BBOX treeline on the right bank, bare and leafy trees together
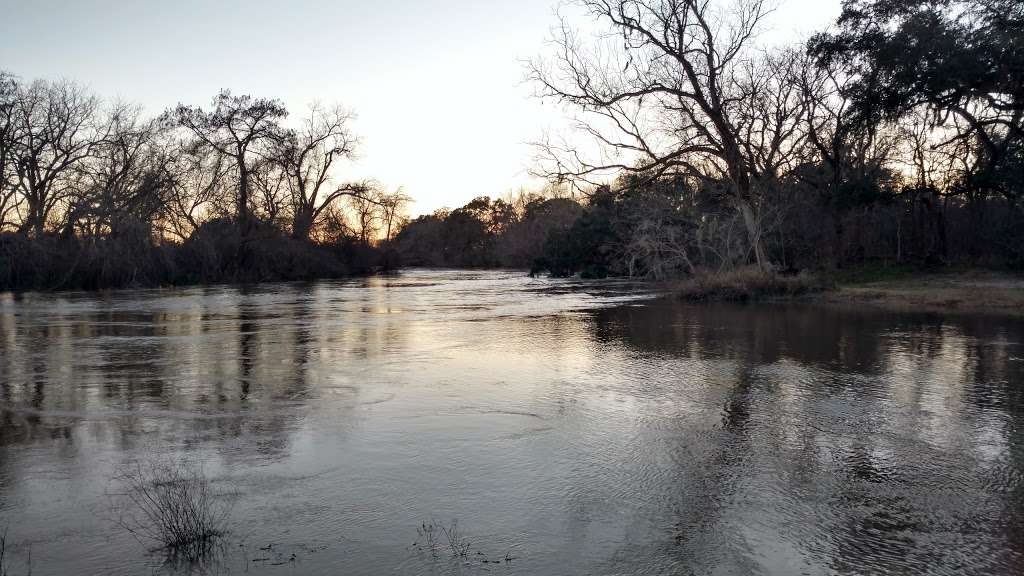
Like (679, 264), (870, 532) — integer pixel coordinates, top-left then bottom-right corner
(458, 0), (1024, 278)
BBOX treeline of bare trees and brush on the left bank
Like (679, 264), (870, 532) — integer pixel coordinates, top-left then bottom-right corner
(0, 77), (410, 290)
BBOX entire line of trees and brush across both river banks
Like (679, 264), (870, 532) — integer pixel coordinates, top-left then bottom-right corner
(9, 0), (1024, 289)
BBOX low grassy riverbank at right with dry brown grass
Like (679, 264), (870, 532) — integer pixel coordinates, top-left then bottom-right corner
(671, 266), (1024, 316)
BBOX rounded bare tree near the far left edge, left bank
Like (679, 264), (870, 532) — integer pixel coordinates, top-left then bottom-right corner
(12, 80), (106, 236)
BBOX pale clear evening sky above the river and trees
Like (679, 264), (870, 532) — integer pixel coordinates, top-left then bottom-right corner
(0, 0), (840, 215)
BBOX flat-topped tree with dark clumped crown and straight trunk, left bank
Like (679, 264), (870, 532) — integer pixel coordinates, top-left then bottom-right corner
(170, 90), (288, 231)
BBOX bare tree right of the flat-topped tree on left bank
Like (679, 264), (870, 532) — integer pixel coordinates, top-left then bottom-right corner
(276, 105), (375, 240)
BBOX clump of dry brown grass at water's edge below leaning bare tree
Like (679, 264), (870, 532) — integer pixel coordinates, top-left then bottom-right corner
(676, 266), (831, 302)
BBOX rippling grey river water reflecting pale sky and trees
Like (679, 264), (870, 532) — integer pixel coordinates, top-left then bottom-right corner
(0, 271), (1024, 576)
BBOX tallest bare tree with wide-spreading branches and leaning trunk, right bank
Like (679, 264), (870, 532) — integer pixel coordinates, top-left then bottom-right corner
(530, 0), (794, 266)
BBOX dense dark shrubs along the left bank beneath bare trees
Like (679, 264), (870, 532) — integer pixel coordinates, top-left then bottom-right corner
(0, 219), (387, 290)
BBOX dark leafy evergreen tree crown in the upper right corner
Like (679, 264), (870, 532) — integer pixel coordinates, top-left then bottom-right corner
(810, 0), (1024, 197)
